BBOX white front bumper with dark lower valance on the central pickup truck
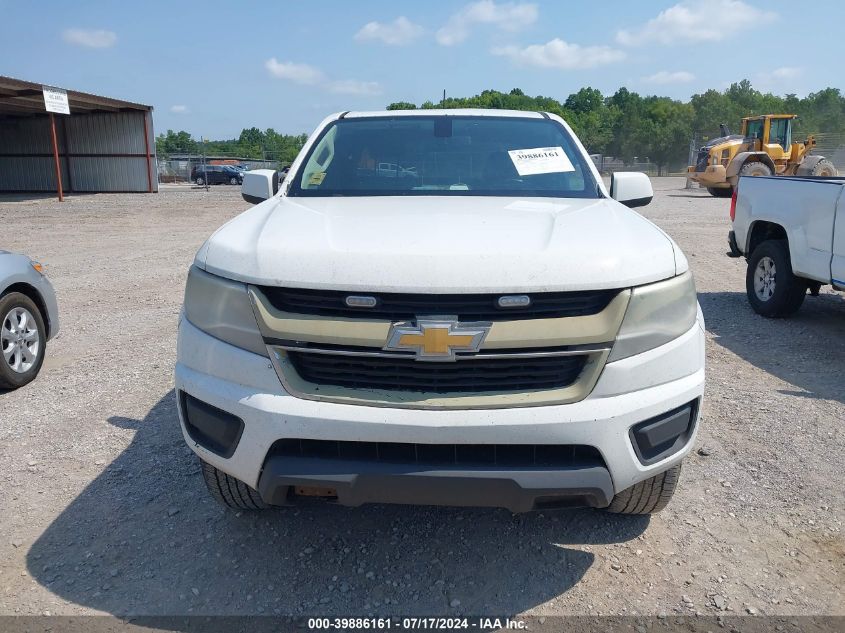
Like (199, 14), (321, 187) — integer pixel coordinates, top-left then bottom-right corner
(176, 310), (704, 511)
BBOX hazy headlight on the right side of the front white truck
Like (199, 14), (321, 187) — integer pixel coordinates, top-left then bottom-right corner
(607, 272), (698, 362)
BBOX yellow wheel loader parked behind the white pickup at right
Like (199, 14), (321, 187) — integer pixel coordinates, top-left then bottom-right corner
(687, 114), (839, 198)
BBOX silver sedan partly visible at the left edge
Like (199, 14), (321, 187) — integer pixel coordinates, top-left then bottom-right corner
(0, 251), (59, 389)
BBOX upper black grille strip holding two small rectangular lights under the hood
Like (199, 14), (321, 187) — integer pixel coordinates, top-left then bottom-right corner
(261, 286), (619, 321)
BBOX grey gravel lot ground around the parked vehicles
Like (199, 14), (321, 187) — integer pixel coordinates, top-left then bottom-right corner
(0, 178), (845, 615)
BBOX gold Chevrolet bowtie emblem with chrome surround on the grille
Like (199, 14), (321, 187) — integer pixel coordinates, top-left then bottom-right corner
(384, 319), (490, 361)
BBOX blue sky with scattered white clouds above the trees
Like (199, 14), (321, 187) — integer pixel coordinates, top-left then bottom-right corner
(0, 0), (845, 138)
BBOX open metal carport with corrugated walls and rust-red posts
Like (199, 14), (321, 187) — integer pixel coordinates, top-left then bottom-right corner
(0, 76), (158, 199)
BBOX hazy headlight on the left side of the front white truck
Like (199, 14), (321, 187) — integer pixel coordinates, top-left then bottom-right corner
(185, 266), (267, 356)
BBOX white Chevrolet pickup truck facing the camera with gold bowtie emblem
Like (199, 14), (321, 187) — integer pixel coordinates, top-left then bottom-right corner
(176, 110), (704, 514)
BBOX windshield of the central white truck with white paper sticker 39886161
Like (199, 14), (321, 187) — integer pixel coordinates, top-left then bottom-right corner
(288, 115), (601, 198)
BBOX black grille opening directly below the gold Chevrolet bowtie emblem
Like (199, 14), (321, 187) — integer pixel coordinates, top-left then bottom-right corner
(288, 352), (587, 393)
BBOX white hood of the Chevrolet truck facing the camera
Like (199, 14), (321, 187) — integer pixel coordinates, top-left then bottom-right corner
(201, 196), (686, 293)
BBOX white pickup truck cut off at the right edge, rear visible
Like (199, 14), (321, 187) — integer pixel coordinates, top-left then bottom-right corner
(728, 177), (845, 317)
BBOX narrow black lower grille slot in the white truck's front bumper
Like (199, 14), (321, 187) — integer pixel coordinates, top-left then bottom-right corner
(270, 438), (604, 467)
